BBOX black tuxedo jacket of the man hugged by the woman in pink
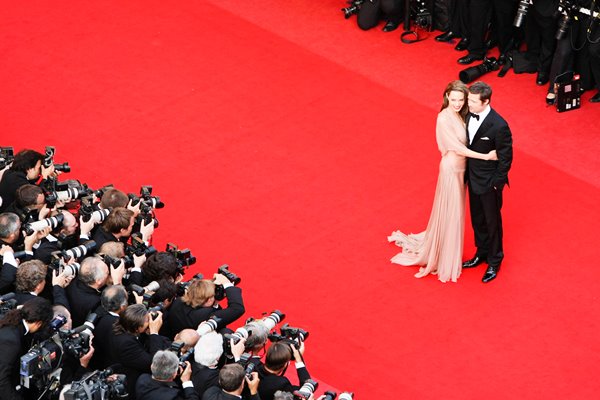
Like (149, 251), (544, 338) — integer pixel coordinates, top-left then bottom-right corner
(465, 108), (513, 194)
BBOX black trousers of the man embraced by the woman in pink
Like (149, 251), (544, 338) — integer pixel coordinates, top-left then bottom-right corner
(469, 186), (504, 266)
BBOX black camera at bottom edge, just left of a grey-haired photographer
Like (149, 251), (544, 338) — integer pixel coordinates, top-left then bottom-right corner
(64, 368), (129, 400)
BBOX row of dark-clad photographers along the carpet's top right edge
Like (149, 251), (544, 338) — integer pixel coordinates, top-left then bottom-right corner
(342, 0), (600, 105)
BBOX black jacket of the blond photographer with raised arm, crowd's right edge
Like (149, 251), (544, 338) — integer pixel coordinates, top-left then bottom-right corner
(161, 286), (245, 337)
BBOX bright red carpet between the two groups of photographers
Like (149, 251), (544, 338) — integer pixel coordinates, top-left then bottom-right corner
(0, 0), (600, 399)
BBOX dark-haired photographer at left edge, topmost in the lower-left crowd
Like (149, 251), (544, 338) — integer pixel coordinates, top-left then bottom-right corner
(0, 149), (54, 212)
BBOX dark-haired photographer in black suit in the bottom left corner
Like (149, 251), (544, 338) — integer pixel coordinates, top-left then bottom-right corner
(0, 297), (53, 400)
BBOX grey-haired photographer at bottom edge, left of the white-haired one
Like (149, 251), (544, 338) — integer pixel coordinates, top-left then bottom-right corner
(135, 350), (199, 400)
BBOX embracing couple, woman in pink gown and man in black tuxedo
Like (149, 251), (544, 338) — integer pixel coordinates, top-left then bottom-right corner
(388, 81), (513, 282)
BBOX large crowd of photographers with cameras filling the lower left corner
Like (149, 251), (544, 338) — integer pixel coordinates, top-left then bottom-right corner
(0, 147), (353, 400)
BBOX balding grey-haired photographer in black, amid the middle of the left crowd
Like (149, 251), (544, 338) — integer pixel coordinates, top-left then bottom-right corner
(67, 257), (109, 326)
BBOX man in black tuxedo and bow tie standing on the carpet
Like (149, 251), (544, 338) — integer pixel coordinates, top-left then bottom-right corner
(463, 82), (513, 283)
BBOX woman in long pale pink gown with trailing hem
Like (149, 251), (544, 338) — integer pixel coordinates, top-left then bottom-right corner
(388, 81), (496, 282)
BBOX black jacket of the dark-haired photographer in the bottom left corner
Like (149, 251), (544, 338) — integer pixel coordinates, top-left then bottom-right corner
(0, 323), (31, 400)
